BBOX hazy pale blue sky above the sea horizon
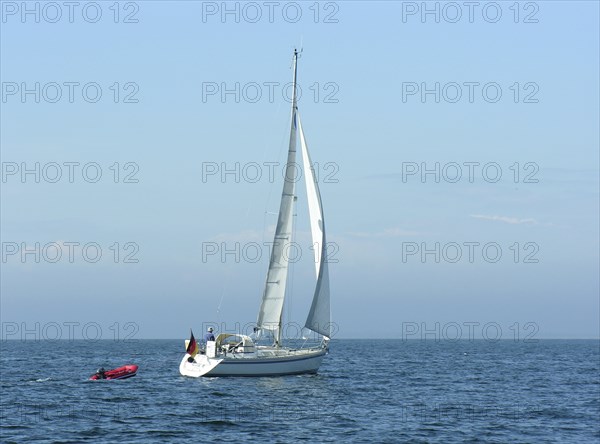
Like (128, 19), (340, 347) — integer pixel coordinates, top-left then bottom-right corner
(0, 1), (600, 339)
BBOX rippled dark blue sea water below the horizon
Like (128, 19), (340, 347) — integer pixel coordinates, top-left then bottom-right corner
(0, 340), (600, 443)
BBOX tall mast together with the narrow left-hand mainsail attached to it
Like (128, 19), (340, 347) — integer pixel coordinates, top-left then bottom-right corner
(256, 49), (298, 345)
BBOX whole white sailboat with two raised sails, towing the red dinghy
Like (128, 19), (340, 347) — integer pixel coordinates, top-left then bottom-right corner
(179, 50), (332, 377)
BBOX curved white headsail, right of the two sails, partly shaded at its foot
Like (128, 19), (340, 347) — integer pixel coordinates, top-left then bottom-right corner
(297, 115), (331, 337)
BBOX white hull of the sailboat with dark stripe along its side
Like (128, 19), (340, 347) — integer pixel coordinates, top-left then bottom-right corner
(179, 348), (327, 378)
